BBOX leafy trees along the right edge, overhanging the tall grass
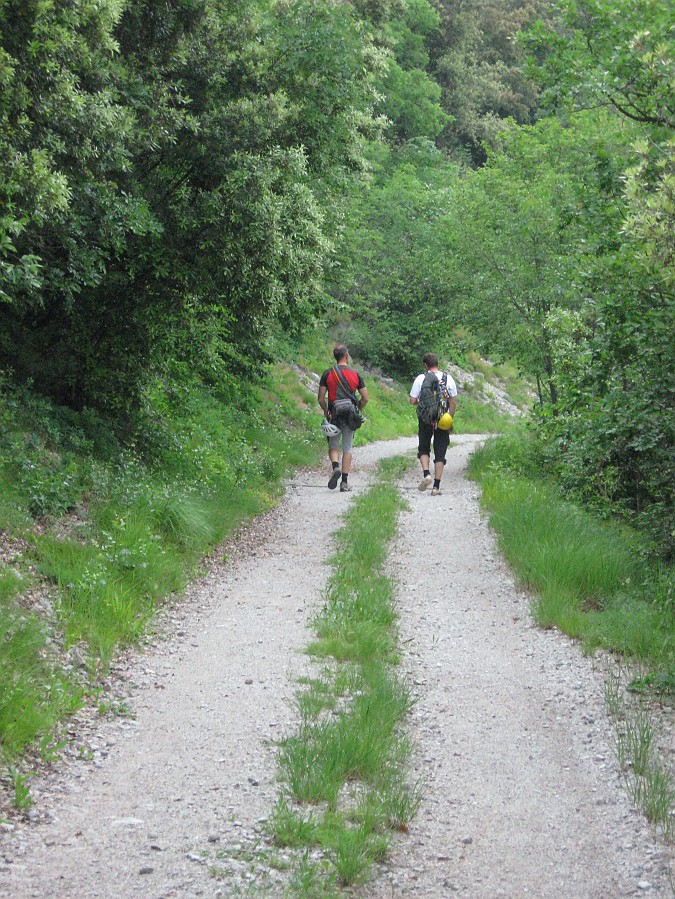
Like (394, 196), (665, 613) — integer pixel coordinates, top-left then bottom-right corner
(527, 0), (675, 555)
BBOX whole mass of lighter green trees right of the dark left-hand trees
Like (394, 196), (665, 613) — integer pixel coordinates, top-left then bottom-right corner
(329, 0), (675, 556)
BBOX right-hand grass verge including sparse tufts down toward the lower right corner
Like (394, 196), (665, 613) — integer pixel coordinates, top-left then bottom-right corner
(469, 438), (675, 839)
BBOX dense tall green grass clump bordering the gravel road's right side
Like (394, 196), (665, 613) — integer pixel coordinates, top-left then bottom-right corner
(470, 441), (675, 672)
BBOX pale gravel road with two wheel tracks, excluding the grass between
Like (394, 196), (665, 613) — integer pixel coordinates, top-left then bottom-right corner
(0, 437), (673, 899)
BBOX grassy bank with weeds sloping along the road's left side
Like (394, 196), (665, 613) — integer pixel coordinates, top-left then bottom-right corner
(0, 368), (324, 763)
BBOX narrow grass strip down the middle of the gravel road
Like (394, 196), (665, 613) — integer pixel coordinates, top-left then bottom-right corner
(269, 459), (420, 897)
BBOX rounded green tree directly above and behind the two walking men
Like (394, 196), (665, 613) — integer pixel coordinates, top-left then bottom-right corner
(328, 139), (458, 377)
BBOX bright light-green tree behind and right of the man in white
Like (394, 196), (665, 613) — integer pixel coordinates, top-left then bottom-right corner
(444, 120), (616, 403)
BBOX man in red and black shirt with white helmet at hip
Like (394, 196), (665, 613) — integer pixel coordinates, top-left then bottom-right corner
(317, 344), (368, 493)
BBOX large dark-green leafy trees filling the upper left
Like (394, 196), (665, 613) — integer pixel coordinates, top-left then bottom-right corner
(0, 0), (386, 415)
